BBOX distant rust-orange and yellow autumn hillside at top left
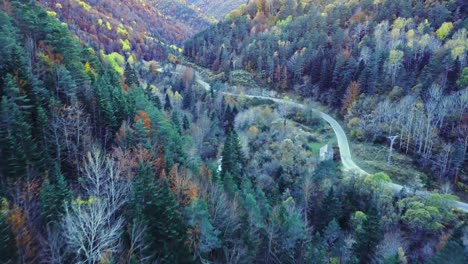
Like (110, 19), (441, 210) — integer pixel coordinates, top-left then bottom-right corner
(38, 0), (214, 60)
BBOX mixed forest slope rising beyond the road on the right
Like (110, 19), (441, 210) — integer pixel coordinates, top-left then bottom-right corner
(184, 0), (468, 194)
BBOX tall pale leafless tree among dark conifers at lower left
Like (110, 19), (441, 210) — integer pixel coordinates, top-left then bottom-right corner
(62, 149), (129, 264)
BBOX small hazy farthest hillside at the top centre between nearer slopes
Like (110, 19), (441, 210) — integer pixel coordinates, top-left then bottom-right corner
(187, 0), (249, 20)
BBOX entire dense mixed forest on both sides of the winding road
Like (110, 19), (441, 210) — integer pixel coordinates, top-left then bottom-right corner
(0, 0), (468, 264)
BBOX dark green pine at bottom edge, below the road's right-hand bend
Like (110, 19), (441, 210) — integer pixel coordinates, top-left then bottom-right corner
(353, 207), (384, 263)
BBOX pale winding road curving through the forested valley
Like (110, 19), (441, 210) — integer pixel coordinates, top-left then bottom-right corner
(196, 75), (468, 212)
